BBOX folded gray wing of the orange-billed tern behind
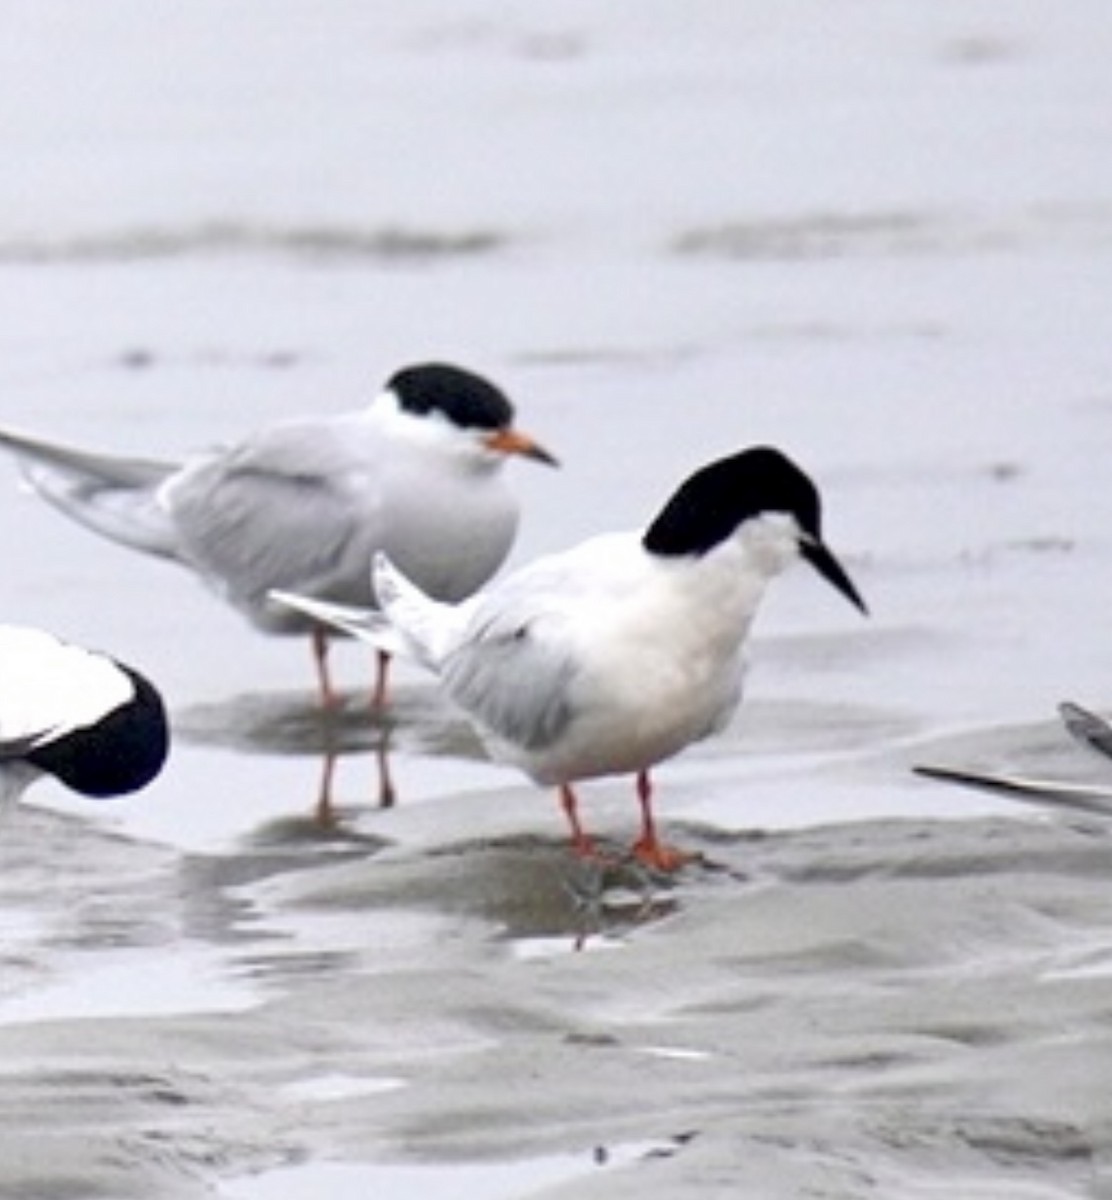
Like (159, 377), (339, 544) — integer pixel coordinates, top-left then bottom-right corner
(164, 422), (377, 607)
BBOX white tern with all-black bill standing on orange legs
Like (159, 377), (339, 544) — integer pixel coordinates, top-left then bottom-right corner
(278, 448), (865, 869)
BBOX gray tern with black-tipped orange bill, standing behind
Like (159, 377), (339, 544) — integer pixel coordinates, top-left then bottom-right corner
(0, 364), (555, 707)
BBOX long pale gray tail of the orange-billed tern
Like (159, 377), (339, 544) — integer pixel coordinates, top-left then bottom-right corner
(0, 430), (179, 559)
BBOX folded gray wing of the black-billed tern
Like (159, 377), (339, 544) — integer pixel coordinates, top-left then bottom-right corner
(441, 604), (577, 750)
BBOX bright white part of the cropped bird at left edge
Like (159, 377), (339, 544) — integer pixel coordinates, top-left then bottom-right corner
(0, 625), (134, 740)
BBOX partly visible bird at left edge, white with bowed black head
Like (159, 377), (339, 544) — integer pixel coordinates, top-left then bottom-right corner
(0, 625), (169, 799)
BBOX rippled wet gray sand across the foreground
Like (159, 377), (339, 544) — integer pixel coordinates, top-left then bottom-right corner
(0, 792), (1112, 1200)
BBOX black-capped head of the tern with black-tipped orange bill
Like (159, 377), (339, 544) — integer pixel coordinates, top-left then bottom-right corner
(384, 362), (558, 467)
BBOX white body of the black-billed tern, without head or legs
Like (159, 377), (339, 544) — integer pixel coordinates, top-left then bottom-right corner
(388, 533), (763, 785)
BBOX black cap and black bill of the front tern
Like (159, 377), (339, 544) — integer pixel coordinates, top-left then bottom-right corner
(643, 446), (866, 612)
